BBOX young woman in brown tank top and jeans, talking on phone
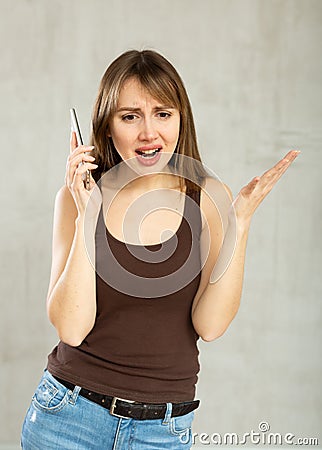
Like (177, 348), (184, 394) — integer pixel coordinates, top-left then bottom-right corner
(21, 50), (298, 450)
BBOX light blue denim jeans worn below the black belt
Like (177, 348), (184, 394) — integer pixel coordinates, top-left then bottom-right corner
(21, 370), (194, 450)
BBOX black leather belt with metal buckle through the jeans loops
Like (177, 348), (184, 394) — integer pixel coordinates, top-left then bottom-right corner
(55, 377), (200, 420)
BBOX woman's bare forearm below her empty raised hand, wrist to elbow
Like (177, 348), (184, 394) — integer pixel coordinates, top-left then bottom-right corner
(192, 224), (249, 341)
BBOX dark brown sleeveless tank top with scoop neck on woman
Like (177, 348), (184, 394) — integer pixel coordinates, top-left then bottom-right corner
(47, 184), (201, 403)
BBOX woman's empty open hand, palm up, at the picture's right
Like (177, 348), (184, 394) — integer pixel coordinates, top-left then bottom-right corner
(233, 150), (300, 225)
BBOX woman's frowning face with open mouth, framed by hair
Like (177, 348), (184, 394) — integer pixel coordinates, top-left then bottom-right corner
(110, 78), (180, 170)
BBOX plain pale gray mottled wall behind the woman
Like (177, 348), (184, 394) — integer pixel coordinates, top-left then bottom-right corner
(0, 0), (322, 449)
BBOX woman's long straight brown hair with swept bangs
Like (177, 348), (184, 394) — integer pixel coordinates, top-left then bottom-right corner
(91, 50), (208, 190)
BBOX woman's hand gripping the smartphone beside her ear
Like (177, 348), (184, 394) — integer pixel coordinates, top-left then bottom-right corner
(65, 131), (102, 217)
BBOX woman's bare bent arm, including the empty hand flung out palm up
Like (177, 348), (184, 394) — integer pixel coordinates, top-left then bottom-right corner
(192, 151), (298, 341)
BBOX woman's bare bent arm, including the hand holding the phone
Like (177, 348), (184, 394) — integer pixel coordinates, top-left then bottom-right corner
(47, 134), (100, 346)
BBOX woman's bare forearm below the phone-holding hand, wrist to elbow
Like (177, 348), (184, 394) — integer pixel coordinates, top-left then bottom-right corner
(47, 217), (96, 346)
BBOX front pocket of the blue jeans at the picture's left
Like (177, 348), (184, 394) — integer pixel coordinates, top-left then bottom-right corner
(32, 374), (72, 413)
